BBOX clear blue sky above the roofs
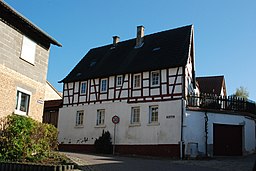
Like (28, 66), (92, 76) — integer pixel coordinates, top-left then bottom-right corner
(5, 0), (256, 100)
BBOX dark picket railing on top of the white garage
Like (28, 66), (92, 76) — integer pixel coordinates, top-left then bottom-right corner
(187, 94), (256, 115)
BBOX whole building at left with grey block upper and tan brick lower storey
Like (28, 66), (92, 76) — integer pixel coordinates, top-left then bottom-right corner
(0, 1), (61, 121)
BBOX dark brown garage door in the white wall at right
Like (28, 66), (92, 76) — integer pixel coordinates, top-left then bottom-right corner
(213, 124), (243, 156)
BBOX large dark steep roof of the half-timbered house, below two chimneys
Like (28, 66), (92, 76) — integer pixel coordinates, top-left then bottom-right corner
(61, 25), (193, 83)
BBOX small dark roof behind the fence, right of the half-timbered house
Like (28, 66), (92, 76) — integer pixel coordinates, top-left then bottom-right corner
(196, 76), (226, 96)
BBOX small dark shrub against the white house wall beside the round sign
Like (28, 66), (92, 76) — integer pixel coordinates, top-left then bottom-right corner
(94, 130), (113, 154)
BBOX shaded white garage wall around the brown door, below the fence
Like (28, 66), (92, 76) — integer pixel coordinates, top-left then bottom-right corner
(183, 110), (255, 156)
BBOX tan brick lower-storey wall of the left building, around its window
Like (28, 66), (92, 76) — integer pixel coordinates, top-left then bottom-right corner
(0, 65), (45, 121)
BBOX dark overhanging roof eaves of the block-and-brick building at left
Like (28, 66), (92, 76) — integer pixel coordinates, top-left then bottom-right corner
(0, 0), (62, 49)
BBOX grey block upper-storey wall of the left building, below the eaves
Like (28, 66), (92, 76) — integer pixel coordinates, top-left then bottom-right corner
(0, 21), (49, 83)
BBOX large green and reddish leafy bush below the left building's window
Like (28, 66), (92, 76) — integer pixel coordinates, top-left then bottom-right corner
(0, 114), (58, 162)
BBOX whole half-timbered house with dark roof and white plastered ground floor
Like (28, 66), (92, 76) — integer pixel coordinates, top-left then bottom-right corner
(58, 25), (195, 156)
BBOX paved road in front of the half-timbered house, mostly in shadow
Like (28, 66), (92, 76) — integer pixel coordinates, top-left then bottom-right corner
(63, 153), (256, 171)
